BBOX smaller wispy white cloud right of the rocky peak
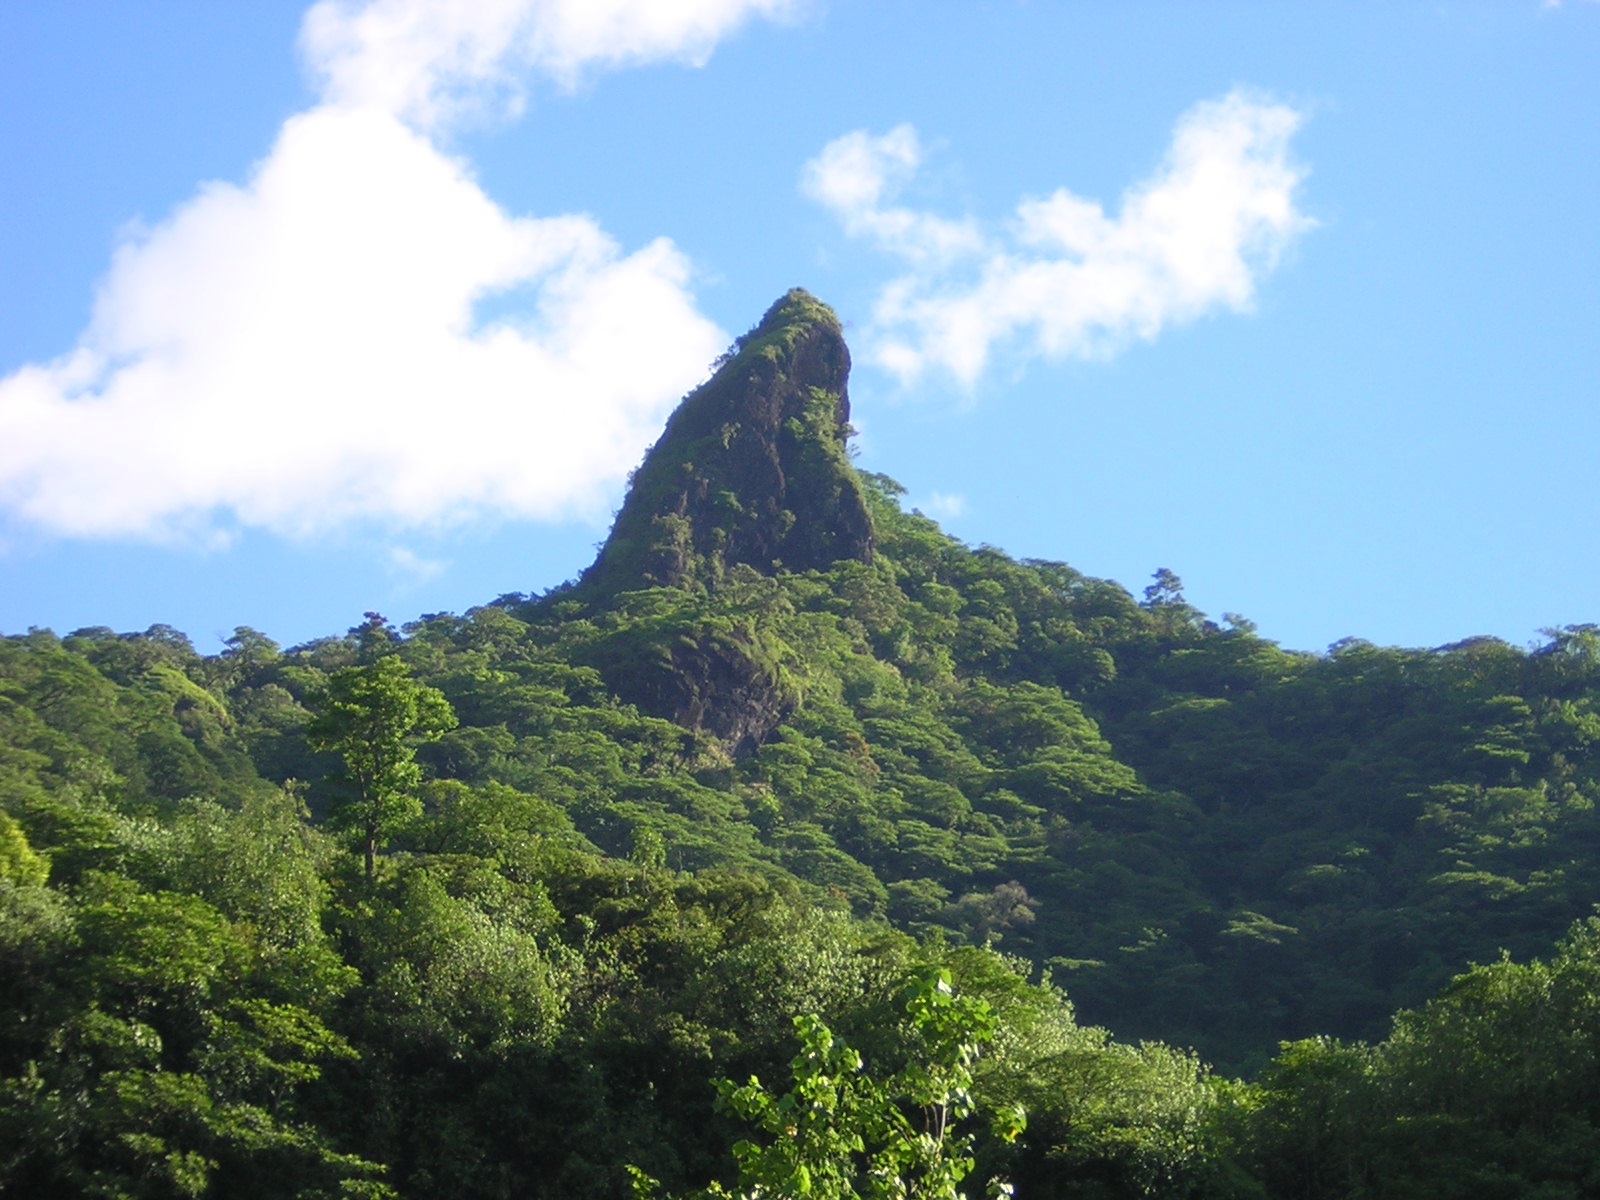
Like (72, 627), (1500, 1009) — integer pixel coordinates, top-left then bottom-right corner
(802, 91), (1312, 384)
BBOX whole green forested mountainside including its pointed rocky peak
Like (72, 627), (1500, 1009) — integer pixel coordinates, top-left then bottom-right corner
(0, 293), (1600, 1197)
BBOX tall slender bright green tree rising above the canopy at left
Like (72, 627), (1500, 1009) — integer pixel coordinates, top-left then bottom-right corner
(306, 654), (456, 882)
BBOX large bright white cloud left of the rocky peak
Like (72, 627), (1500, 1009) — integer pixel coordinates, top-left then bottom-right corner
(0, 0), (782, 541)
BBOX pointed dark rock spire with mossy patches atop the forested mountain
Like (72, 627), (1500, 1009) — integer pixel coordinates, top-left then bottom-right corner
(582, 288), (872, 594)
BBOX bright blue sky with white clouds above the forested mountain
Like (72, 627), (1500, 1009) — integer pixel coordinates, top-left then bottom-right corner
(0, 0), (1600, 650)
